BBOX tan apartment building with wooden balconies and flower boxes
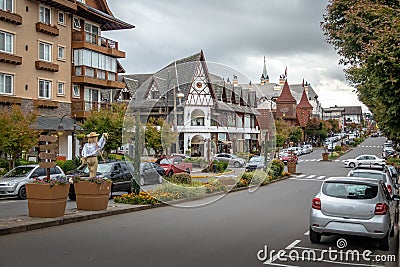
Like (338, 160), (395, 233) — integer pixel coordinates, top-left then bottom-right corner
(0, 0), (134, 159)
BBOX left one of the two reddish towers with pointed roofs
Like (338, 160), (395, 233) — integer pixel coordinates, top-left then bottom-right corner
(276, 81), (297, 122)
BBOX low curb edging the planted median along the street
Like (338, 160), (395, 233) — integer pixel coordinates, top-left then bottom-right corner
(0, 176), (290, 236)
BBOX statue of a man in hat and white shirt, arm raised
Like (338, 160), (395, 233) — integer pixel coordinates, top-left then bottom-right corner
(82, 132), (108, 177)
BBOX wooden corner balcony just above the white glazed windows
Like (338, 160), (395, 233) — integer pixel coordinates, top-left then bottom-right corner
(72, 31), (125, 58)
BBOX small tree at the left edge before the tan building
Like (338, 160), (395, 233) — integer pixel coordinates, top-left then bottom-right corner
(0, 105), (39, 168)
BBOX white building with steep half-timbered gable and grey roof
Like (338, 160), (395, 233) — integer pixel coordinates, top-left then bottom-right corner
(124, 51), (260, 157)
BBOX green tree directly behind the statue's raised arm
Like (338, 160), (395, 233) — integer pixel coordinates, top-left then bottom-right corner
(82, 104), (126, 154)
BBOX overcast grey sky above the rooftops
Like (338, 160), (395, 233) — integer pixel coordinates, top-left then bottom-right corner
(104, 0), (368, 110)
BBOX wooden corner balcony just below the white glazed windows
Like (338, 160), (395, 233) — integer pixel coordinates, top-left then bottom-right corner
(72, 66), (125, 89)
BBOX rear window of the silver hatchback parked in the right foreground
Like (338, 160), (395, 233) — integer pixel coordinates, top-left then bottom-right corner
(322, 182), (378, 199)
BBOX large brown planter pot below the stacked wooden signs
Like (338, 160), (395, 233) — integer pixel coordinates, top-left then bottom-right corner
(25, 175), (70, 218)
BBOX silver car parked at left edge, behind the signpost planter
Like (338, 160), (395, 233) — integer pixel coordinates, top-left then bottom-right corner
(0, 165), (65, 199)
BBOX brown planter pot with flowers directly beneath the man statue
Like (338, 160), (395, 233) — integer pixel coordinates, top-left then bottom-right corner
(73, 176), (112, 213)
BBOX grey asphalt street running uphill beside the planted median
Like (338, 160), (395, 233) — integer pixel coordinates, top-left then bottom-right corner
(0, 138), (398, 267)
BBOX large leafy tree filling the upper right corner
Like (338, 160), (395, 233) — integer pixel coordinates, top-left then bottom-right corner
(321, 0), (400, 141)
